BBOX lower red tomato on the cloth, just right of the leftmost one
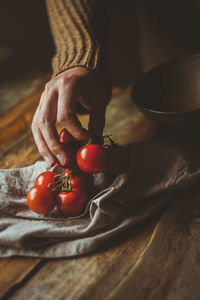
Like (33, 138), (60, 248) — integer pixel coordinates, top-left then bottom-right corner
(57, 187), (87, 217)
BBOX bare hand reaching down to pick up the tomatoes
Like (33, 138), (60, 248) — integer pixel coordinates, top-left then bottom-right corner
(31, 67), (110, 166)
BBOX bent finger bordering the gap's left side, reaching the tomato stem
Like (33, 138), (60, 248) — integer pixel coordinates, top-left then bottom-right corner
(57, 88), (89, 141)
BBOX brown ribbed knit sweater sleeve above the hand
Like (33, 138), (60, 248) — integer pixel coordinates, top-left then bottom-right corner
(46, 0), (104, 77)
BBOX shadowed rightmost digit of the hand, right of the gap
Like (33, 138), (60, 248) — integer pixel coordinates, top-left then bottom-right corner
(88, 106), (106, 136)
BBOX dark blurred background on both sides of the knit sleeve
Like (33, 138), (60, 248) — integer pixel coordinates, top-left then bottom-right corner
(0, 0), (200, 85)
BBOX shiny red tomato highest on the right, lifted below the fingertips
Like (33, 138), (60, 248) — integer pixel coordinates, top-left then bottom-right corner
(76, 144), (107, 174)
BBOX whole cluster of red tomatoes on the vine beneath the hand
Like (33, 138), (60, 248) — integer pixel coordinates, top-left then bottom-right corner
(27, 128), (128, 217)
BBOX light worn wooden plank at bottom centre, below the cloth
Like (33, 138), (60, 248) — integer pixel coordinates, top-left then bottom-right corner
(10, 219), (155, 300)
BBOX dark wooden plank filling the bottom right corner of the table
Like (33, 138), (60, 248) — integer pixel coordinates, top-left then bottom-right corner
(105, 189), (200, 300)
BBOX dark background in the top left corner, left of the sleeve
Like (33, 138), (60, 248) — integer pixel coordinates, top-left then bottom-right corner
(0, 0), (55, 75)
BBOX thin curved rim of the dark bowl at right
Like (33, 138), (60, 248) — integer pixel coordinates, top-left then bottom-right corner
(131, 53), (200, 115)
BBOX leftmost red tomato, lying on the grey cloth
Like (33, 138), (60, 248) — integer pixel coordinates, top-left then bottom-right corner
(27, 185), (56, 214)
